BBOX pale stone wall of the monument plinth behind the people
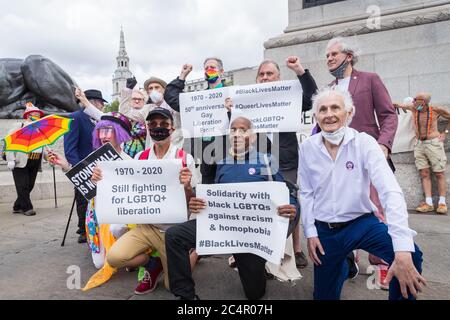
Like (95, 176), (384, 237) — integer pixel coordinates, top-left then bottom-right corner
(264, 0), (450, 208)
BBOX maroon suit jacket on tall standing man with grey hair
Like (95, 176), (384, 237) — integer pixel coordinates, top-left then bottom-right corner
(332, 70), (398, 150)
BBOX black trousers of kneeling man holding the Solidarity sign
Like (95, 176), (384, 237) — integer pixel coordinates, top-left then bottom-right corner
(165, 214), (299, 300)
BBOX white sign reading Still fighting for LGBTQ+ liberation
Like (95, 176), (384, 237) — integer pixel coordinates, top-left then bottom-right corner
(95, 159), (187, 224)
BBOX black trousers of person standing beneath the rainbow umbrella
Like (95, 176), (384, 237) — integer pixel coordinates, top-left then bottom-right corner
(13, 158), (41, 211)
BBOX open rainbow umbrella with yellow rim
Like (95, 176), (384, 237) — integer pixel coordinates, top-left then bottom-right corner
(3, 115), (72, 153)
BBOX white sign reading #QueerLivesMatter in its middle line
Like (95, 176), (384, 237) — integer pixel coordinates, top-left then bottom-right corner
(230, 80), (303, 132)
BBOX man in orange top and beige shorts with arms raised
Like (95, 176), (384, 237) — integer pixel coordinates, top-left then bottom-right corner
(394, 93), (450, 214)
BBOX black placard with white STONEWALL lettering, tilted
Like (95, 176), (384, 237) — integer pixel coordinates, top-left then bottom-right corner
(66, 143), (122, 201)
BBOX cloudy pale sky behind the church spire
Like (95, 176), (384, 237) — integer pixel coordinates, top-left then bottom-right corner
(0, 0), (288, 100)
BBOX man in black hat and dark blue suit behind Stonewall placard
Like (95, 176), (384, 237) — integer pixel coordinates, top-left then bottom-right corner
(64, 90), (107, 243)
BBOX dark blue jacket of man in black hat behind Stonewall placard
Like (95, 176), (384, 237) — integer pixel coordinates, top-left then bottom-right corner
(64, 110), (95, 166)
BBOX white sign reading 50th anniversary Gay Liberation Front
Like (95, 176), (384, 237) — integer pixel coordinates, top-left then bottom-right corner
(180, 88), (229, 138)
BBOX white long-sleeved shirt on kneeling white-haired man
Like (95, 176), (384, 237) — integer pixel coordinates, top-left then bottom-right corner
(299, 128), (417, 252)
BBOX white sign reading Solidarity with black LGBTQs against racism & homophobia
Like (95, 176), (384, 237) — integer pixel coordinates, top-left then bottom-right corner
(196, 182), (289, 265)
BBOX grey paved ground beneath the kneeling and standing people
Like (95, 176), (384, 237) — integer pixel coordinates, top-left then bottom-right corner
(0, 198), (450, 300)
